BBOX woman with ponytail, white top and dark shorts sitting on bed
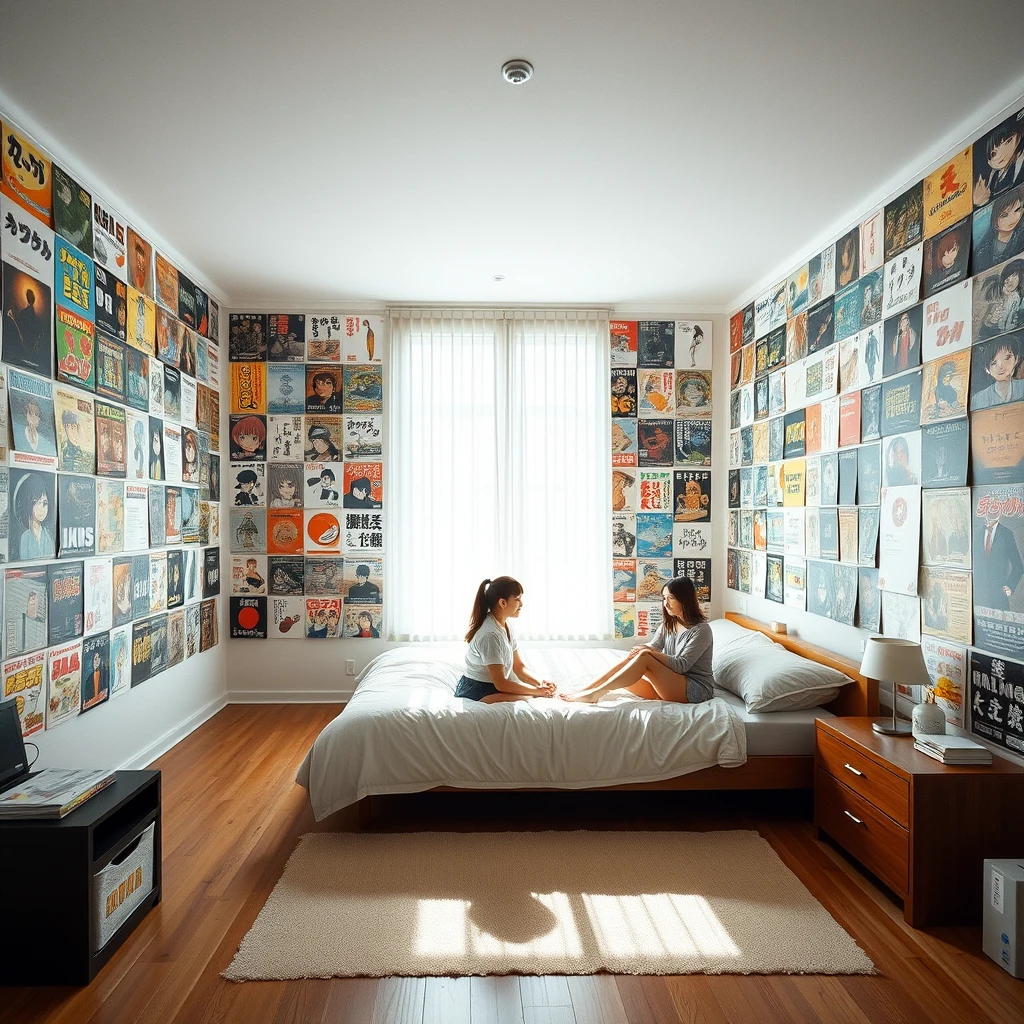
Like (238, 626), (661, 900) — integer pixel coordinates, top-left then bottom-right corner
(455, 577), (555, 703)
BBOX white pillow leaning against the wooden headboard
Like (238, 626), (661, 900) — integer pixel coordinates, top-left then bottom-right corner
(712, 630), (850, 712)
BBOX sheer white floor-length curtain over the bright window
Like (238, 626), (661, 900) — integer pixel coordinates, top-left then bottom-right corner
(384, 309), (612, 640)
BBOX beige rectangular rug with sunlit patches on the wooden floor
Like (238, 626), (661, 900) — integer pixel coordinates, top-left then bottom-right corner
(224, 831), (874, 981)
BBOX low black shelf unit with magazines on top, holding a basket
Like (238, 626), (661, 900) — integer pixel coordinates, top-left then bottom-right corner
(0, 770), (161, 985)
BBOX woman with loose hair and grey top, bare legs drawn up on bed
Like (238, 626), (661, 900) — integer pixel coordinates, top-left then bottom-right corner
(559, 577), (715, 703)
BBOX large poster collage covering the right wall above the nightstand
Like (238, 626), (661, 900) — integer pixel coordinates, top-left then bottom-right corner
(727, 109), (1024, 754)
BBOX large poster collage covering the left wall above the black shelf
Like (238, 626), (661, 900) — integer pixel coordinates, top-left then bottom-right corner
(0, 119), (220, 736)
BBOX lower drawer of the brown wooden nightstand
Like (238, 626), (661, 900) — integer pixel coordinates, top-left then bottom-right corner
(814, 770), (909, 895)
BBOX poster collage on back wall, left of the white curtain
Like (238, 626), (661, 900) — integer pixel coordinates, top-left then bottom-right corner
(225, 311), (384, 640)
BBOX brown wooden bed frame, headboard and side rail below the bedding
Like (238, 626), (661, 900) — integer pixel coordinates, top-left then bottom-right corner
(358, 611), (879, 824)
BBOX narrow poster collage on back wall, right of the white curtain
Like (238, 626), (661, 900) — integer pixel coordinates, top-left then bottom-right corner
(609, 321), (712, 638)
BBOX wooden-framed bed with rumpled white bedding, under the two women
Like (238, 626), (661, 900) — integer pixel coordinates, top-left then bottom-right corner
(296, 612), (878, 820)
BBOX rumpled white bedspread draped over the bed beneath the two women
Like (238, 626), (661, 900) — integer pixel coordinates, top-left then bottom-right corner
(296, 645), (746, 820)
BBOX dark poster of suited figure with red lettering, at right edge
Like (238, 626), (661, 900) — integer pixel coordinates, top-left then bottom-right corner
(972, 483), (1024, 654)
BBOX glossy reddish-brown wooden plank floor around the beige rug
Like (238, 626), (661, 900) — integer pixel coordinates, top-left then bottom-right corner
(0, 706), (1024, 1024)
